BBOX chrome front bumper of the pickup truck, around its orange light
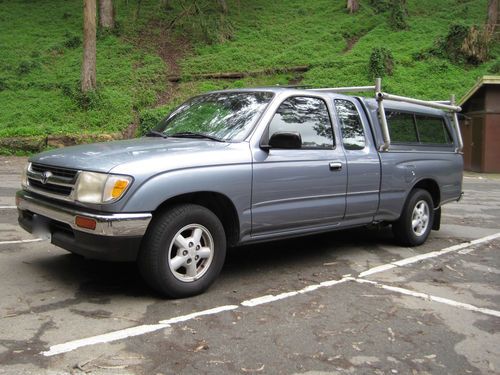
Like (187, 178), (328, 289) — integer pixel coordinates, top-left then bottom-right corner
(16, 190), (152, 237)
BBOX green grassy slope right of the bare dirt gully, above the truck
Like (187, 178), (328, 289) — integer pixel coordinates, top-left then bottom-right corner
(178, 0), (500, 99)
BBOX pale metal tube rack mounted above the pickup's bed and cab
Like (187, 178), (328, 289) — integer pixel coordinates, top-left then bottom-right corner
(311, 78), (463, 152)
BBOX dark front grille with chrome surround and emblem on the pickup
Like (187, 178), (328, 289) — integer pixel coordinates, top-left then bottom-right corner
(28, 163), (78, 199)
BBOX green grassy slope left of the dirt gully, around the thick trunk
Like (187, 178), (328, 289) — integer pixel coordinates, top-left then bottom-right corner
(0, 0), (165, 137)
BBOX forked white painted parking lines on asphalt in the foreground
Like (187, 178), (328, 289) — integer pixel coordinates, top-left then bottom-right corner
(39, 232), (500, 357)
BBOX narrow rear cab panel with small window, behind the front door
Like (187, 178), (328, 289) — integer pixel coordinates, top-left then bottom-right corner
(334, 99), (380, 225)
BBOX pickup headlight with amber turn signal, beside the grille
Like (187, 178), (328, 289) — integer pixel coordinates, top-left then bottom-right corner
(75, 172), (132, 203)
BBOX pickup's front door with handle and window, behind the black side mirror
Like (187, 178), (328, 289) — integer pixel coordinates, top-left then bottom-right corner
(252, 96), (347, 235)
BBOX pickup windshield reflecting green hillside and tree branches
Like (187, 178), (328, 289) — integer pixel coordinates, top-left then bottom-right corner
(155, 92), (273, 141)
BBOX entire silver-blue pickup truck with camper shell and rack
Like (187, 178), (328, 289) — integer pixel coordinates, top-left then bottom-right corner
(16, 80), (463, 297)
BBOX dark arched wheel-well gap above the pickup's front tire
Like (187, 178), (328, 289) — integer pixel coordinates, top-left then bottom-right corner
(153, 191), (240, 246)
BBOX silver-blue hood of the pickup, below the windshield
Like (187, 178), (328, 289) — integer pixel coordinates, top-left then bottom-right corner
(30, 137), (230, 172)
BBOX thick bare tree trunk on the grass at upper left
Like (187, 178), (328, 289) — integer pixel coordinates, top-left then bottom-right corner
(82, 0), (96, 92)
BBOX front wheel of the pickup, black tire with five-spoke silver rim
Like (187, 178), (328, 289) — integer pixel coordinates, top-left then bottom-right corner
(138, 204), (226, 298)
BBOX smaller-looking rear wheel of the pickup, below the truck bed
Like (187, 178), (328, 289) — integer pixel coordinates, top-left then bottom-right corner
(392, 189), (434, 246)
